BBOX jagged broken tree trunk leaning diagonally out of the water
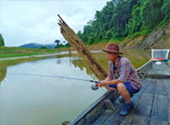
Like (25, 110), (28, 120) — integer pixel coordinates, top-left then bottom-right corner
(58, 15), (107, 80)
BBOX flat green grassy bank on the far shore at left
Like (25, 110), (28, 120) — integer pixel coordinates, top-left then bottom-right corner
(0, 47), (58, 58)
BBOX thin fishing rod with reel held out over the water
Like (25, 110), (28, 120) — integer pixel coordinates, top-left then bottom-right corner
(8, 73), (99, 90)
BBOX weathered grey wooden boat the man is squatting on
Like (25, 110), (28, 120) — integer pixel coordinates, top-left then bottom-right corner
(69, 50), (170, 125)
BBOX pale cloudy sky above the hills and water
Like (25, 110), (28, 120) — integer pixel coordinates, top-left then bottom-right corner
(0, 0), (110, 46)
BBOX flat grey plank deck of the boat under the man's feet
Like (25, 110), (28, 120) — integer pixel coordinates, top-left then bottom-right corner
(95, 78), (170, 125)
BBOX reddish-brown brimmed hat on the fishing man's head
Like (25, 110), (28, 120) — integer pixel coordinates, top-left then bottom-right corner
(103, 43), (123, 54)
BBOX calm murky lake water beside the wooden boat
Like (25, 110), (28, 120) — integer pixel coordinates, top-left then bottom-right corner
(0, 50), (150, 125)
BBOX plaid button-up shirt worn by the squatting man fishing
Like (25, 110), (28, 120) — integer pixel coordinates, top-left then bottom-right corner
(108, 56), (142, 90)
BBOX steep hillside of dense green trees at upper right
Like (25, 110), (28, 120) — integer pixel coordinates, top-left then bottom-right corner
(77, 0), (170, 48)
